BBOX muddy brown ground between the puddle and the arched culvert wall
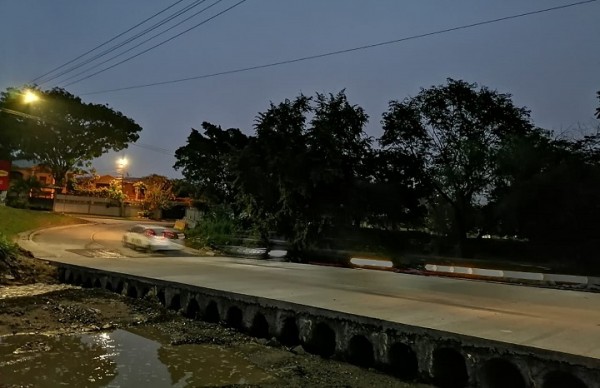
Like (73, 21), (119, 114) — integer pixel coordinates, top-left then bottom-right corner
(0, 257), (432, 387)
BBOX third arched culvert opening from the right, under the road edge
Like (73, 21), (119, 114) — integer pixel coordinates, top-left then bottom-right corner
(432, 348), (469, 388)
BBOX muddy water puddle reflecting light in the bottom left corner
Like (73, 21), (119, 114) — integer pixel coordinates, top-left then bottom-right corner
(0, 328), (274, 388)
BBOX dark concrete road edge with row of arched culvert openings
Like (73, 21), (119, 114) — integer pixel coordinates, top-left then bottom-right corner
(56, 263), (600, 388)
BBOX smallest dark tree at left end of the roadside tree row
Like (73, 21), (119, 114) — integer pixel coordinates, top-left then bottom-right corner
(174, 122), (248, 204)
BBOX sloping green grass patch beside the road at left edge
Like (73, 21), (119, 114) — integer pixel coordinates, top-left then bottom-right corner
(0, 206), (86, 239)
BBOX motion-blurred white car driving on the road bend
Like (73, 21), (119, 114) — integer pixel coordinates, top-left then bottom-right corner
(122, 225), (183, 251)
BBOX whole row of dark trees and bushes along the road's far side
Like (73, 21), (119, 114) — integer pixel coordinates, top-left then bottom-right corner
(175, 79), (600, 273)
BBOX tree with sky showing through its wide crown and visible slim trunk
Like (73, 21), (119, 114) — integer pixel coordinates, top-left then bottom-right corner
(380, 79), (532, 254)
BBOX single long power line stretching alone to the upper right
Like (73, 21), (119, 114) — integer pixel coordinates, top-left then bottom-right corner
(81, 0), (598, 96)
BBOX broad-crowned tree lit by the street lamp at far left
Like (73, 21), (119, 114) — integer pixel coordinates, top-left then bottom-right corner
(0, 88), (142, 185)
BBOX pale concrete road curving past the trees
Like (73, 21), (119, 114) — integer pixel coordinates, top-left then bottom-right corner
(22, 221), (600, 361)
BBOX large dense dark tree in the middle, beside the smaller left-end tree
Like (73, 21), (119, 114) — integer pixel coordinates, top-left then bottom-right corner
(237, 91), (371, 255)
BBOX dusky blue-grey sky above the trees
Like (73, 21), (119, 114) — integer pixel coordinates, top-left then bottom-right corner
(0, 0), (600, 177)
